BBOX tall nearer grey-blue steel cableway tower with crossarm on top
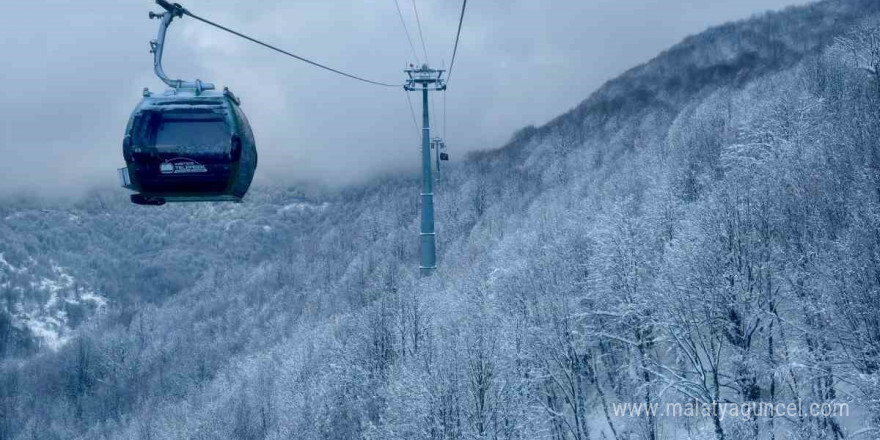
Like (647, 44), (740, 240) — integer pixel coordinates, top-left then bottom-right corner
(403, 64), (446, 276)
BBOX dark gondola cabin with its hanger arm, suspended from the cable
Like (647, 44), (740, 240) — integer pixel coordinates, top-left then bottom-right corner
(119, 1), (257, 206)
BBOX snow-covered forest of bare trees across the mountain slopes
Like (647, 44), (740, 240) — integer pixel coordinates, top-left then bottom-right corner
(0, 0), (880, 440)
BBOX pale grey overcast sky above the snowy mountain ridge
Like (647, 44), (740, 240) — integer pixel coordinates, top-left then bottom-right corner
(0, 0), (803, 199)
